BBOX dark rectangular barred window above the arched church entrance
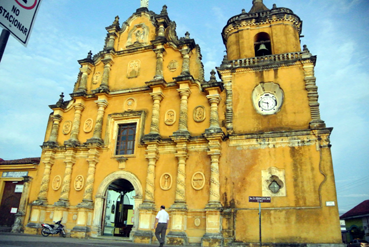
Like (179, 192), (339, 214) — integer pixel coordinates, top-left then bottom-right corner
(115, 124), (136, 155)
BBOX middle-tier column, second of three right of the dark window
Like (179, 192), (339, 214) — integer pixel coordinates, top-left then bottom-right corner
(174, 87), (191, 135)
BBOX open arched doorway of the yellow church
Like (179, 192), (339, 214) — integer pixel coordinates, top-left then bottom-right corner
(101, 178), (136, 237)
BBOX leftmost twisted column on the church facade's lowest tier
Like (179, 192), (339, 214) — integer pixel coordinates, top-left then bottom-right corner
(34, 151), (55, 204)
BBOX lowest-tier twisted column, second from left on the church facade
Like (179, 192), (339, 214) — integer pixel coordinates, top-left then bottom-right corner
(54, 149), (76, 207)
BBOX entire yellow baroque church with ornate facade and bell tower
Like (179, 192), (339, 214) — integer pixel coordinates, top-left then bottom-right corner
(1, 0), (342, 246)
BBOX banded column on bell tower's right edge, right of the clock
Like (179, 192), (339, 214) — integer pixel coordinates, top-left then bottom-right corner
(302, 45), (325, 129)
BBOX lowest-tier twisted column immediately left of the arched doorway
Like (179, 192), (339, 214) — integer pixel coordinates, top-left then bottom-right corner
(78, 148), (100, 208)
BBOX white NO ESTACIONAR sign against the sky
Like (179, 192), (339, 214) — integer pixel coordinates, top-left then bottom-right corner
(0, 0), (41, 46)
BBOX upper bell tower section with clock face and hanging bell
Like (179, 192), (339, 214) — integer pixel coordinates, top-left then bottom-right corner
(218, 0), (325, 133)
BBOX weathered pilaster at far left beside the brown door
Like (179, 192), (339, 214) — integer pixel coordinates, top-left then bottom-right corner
(11, 176), (32, 233)
